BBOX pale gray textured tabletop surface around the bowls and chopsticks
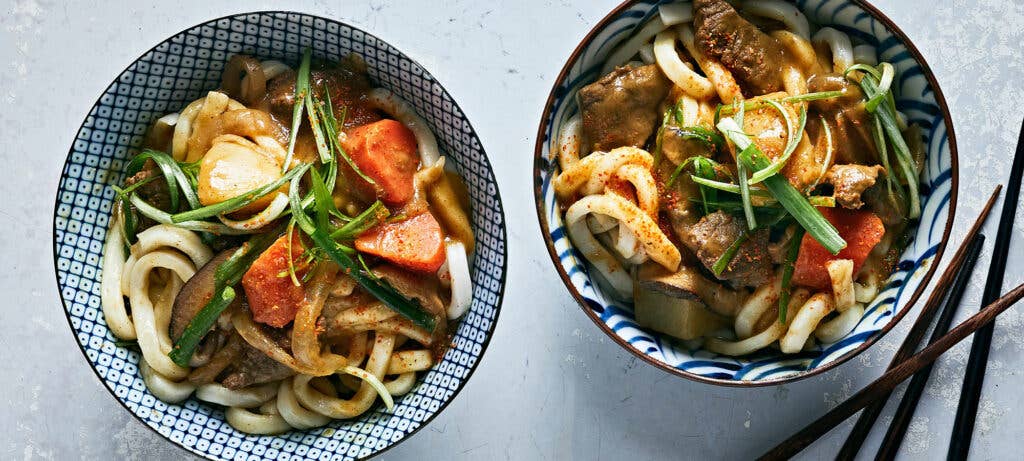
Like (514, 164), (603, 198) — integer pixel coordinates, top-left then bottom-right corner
(0, 0), (1024, 460)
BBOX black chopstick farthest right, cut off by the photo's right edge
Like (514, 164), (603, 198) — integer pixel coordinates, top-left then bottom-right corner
(946, 117), (1024, 460)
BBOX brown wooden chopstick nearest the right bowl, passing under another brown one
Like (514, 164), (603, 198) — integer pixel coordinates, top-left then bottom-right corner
(836, 185), (1002, 461)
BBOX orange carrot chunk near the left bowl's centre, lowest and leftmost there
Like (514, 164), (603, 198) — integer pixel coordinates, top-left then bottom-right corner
(242, 234), (308, 328)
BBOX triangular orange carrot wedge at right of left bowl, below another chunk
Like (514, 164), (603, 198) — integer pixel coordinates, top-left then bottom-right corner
(355, 211), (445, 273)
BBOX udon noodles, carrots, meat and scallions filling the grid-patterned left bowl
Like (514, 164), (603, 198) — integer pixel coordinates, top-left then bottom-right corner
(101, 50), (474, 434)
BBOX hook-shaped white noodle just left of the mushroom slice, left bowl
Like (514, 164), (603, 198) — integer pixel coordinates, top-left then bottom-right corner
(128, 250), (196, 380)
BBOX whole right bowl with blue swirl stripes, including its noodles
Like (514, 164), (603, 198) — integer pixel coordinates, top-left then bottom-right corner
(534, 0), (956, 386)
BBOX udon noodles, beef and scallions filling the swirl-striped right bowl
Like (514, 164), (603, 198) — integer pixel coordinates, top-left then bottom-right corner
(552, 0), (925, 355)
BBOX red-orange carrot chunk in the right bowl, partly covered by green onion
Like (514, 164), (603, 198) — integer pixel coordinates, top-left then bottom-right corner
(793, 208), (886, 290)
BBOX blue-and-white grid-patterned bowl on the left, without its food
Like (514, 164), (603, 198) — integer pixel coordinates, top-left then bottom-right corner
(53, 12), (507, 460)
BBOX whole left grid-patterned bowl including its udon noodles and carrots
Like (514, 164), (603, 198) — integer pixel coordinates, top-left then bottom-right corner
(54, 11), (506, 460)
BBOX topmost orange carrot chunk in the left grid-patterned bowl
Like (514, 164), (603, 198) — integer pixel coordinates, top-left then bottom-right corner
(342, 120), (420, 206)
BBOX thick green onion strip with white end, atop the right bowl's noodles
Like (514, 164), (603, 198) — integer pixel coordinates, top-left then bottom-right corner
(718, 118), (846, 254)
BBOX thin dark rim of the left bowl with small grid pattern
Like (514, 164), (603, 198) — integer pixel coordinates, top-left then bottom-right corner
(51, 9), (508, 460)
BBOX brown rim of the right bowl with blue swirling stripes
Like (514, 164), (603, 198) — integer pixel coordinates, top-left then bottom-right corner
(532, 0), (959, 387)
